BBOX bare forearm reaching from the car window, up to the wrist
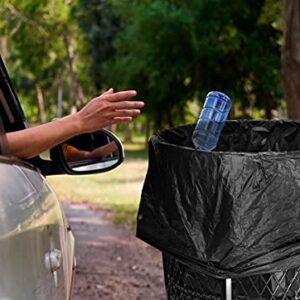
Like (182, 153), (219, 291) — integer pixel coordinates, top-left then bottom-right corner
(7, 114), (82, 159)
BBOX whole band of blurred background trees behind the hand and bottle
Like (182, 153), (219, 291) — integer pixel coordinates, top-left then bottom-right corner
(0, 0), (292, 137)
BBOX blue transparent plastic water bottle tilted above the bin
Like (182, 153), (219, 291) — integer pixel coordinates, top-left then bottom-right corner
(193, 91), (231, 151)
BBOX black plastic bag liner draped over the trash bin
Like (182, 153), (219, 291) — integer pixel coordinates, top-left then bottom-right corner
(137, 121), (300, 278)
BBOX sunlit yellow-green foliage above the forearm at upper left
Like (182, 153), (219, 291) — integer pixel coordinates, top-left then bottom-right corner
(0, 0), (88, 122)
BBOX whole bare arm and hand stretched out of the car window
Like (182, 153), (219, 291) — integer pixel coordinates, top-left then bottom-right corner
(7, 89), (144, 159)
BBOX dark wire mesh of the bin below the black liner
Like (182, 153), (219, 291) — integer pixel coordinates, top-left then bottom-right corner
(163, 254), (300, 300)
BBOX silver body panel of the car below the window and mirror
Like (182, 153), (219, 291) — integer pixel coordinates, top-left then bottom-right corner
(0, 158), (74, 300)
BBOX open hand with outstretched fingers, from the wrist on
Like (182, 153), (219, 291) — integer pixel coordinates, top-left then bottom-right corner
(74, 89), (144, 132)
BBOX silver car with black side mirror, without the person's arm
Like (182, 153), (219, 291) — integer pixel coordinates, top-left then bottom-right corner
(0, 57), (124, 300)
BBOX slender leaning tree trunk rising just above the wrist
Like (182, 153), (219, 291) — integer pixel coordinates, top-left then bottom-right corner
(64, 35), (83, 109)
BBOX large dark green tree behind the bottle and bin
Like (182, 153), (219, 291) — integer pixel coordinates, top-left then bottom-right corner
(103, 0), (281, 128)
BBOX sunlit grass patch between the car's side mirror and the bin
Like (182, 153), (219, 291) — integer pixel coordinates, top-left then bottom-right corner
(48, 139), (148, 227)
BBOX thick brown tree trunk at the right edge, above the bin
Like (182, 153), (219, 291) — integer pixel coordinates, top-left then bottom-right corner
(281, 0), (300, 119)
